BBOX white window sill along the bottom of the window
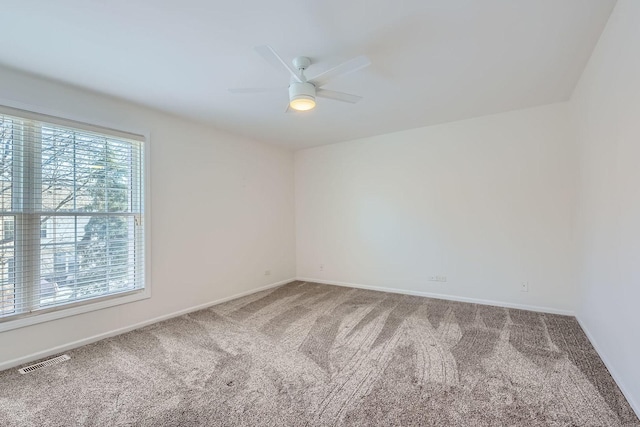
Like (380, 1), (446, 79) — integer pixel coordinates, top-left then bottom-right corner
(0, 287), (151, 332)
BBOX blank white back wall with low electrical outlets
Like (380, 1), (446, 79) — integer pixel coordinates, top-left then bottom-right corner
(295, 103), (576, 312)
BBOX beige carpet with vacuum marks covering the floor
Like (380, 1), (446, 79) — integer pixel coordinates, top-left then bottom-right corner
(0, 282), (640, 427)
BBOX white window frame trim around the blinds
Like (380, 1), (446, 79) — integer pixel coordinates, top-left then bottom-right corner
(0, 98), (151, 332)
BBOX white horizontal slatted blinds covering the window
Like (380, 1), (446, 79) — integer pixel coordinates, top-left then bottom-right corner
(0, 107), (145, 322)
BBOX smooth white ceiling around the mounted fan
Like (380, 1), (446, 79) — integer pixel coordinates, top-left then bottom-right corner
(0, 0), (615, 149)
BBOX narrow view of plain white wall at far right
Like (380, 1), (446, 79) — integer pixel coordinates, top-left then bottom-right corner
(571, 0), (640, 413)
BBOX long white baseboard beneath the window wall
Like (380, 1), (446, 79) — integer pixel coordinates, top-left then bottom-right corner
(0, 278), (296, 371)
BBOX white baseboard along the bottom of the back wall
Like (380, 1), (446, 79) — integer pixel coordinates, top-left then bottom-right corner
(297, 277), (575, 316)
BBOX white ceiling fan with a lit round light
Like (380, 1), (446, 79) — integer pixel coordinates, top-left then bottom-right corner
(229, 45), (371, 111)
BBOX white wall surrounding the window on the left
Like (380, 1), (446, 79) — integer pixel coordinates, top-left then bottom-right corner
(0, 68), (295, 369)
